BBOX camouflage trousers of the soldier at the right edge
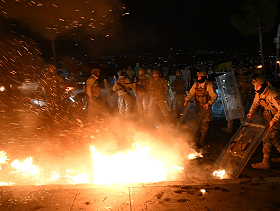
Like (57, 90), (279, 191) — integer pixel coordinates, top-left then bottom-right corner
(262, 123), (280, 156)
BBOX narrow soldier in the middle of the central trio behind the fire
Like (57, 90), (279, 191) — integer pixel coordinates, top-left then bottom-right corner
(136, 67), (149, 120)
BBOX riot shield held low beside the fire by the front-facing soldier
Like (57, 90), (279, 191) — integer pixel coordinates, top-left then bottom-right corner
(177, 102), (205, 143)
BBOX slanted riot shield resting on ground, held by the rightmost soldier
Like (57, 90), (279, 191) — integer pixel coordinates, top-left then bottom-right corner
(214, 114), (267, 178)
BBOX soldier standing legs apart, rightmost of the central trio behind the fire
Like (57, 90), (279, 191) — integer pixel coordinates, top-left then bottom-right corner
(148, 70), (169, 121)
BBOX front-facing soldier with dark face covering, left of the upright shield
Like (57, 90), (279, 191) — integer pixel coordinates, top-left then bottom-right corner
(184, 70), (218, 147)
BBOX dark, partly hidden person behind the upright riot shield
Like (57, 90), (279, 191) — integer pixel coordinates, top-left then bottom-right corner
(222, 68), (252, 133)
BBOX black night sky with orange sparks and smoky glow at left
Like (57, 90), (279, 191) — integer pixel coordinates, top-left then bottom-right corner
(0, 0), (280, 57)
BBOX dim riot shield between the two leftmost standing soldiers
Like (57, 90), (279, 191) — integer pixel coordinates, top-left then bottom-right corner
(104, 77), (118, 112)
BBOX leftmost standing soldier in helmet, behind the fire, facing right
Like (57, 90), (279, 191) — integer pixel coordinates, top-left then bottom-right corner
(85, 68), (101, 117)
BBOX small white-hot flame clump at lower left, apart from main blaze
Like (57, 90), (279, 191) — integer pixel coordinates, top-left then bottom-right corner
(11, 157), (39, 176)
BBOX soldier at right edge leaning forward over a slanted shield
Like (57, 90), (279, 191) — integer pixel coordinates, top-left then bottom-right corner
(247, 76), (280, 170)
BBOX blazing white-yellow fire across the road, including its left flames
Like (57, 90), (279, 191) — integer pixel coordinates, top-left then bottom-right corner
(0, 143), (188, 185)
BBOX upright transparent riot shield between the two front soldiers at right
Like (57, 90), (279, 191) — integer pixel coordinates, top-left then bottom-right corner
(216, 71), (245, 120)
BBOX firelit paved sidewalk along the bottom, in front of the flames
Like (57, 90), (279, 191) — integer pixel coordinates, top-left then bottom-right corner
(0, 177), (280, 211)
